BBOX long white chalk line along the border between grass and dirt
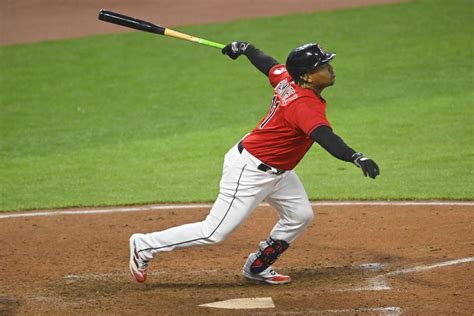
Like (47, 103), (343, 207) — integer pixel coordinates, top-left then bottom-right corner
(0, 201), (474, 219)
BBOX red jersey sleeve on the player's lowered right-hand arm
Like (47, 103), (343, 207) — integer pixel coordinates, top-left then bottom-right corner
(287, 102), (331, 137)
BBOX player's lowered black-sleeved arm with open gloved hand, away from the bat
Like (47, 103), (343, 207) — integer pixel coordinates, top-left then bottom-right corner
(310, 125), (380, 179)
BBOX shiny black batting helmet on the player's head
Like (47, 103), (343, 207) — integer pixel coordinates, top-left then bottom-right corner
(286, 43), (336, 83)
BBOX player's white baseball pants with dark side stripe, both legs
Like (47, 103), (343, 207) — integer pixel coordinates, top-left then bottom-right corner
(136, 145), (313, 259)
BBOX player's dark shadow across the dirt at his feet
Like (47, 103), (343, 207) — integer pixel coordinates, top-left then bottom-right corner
(51, 266), (388, 298)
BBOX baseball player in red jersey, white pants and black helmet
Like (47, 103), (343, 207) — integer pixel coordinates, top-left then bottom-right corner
(130, 42), (379, 284)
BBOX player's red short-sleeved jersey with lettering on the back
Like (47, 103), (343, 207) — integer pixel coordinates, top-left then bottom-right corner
(243, 65), (330, 170)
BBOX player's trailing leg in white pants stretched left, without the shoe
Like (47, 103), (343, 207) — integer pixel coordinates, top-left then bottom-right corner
(134, 147), (276, 278)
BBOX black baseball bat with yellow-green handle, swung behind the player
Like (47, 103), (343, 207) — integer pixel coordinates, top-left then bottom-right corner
(99, 9), (225, 49)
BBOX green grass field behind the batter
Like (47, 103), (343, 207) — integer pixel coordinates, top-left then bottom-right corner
(0, 0), (474, 210)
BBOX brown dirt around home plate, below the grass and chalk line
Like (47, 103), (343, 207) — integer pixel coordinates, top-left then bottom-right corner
(0, 206), (474, 315)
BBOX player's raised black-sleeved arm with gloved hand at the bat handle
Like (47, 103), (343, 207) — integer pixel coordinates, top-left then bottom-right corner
(222, 42), (279, 76)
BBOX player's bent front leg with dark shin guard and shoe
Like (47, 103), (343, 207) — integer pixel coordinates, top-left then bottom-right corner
(243, 171), (313, 284)
